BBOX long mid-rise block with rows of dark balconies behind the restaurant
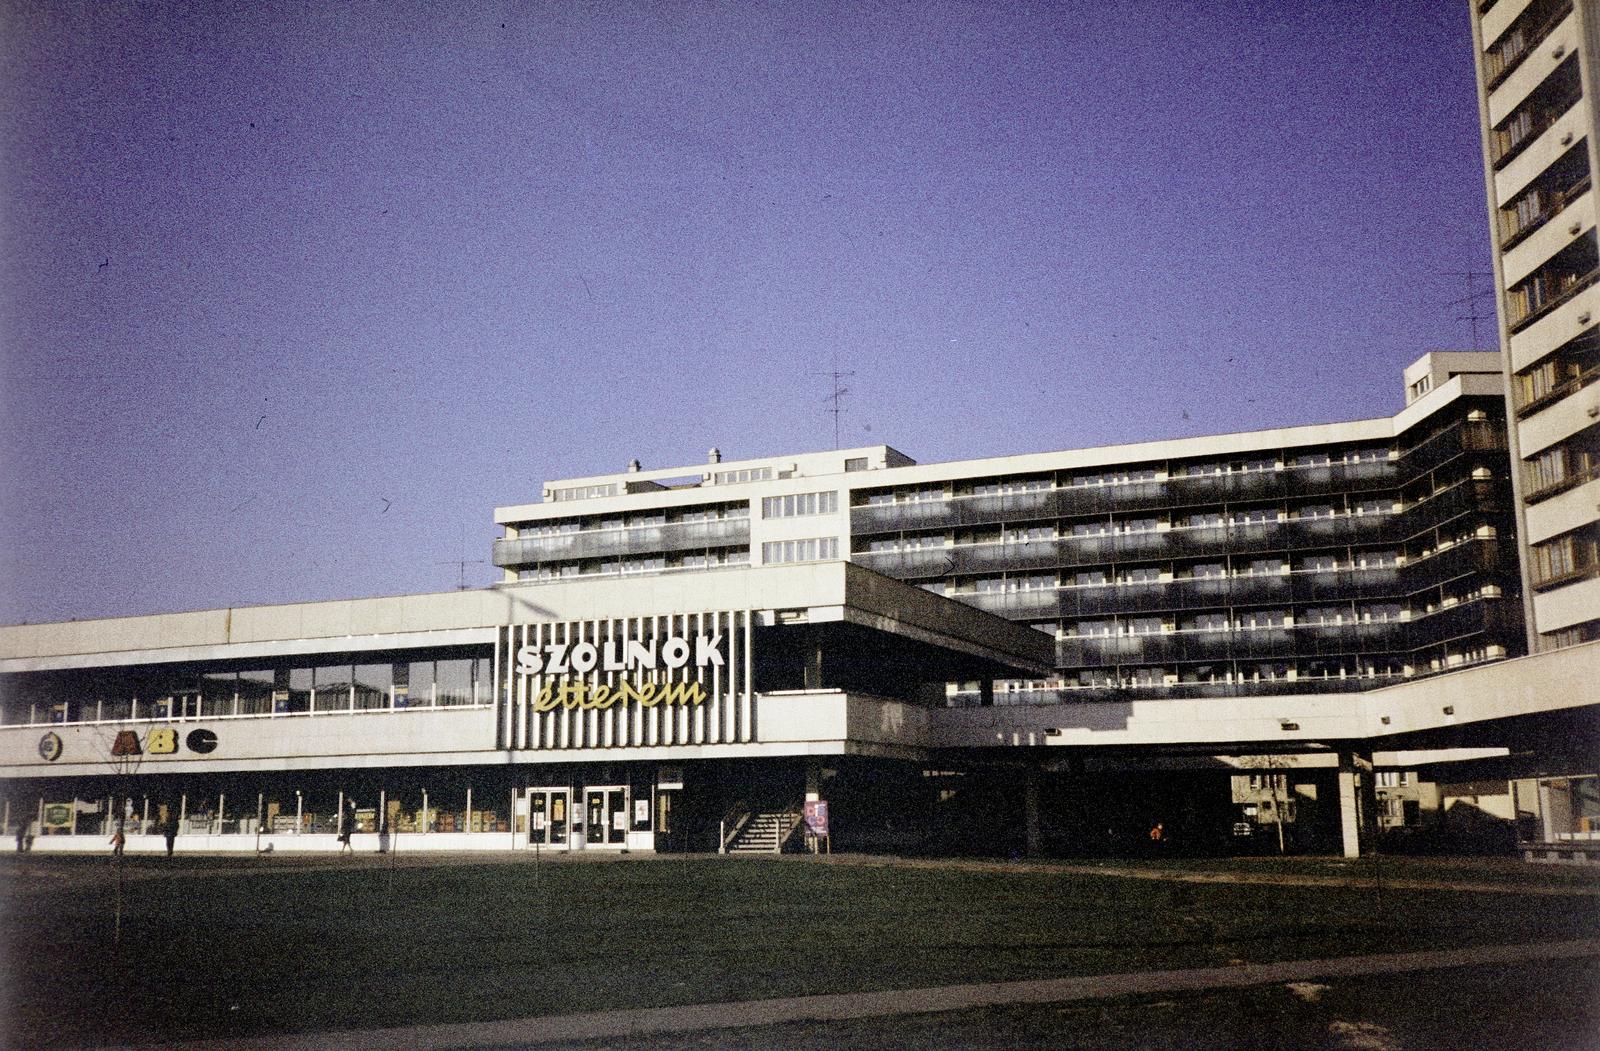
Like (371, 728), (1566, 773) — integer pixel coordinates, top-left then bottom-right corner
(494, 354), (1523, 705)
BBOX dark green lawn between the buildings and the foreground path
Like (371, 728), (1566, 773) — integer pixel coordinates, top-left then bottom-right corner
(0, 856), (1600, 1046)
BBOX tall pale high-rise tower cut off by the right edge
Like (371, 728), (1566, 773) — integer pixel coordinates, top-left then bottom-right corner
(1470, 0), (1600, 651)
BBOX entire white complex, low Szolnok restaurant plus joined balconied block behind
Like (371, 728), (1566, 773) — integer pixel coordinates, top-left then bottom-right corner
(0, 354), (1600, 854)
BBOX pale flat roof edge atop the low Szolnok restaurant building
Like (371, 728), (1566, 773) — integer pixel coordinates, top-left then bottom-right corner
(0, 561), (1054, 677)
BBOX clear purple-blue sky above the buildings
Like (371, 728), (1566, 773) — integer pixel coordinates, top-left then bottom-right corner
(0, 0), (1494, 622)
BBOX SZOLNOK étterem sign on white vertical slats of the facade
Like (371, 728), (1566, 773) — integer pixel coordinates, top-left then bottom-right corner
(496, 611), (755, 749)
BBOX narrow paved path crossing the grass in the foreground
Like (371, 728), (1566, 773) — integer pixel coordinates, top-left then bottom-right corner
(106, 939), (1600, 1051)
